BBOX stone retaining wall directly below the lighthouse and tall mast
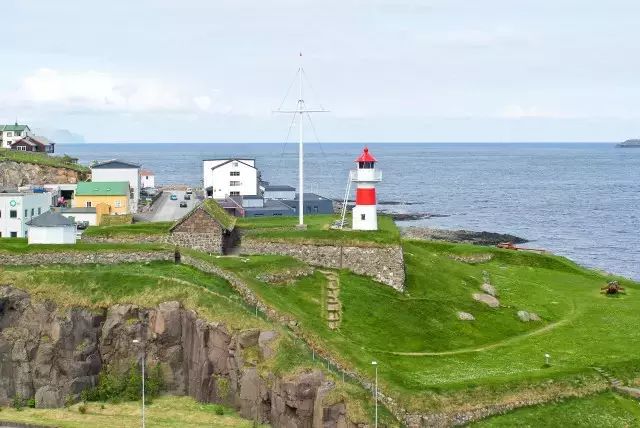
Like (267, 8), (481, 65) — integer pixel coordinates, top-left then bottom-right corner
(240, 241), (405, 291)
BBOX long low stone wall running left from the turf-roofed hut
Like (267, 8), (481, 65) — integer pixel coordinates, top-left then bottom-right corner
(0, 250), (175, 266)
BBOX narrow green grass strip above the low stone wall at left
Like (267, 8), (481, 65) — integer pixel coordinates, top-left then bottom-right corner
(0, 239), (169, 254)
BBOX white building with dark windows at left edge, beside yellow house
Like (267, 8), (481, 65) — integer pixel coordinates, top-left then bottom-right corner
(0, 191), (53, 238)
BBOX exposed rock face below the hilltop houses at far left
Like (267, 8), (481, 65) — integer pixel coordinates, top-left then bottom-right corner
(0, 161), (88, 188)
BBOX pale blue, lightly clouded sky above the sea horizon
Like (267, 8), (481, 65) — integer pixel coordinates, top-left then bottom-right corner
(0, 0), (640, 143)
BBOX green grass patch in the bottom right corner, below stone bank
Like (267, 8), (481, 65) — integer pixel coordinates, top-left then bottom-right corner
(471, 392), (640, 428)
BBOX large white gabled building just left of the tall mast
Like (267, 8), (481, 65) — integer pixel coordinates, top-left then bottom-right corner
(202, 159), (260, 199)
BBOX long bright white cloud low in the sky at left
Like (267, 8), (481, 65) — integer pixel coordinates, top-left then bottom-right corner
(0, 68), (226, 113)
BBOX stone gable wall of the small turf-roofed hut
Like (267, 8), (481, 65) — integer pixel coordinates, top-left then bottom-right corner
(169, 209), (225, 254)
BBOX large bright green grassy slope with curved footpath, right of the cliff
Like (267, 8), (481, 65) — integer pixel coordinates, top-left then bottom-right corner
(201, 241), (640, 410)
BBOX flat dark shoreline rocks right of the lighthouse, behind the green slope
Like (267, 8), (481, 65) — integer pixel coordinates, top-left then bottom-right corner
(401, 226), (528, 245)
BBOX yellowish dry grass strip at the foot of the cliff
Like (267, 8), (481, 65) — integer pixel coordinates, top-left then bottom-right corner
(0, 396), (261, 428)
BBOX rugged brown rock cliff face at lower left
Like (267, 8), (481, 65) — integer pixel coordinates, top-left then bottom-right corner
(0, 285), (356, 428)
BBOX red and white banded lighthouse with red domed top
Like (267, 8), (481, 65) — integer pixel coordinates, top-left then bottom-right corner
(351, 147), (382, 230)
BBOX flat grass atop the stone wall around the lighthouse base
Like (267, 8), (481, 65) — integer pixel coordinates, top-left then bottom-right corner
(237, 214), (400, 246)
